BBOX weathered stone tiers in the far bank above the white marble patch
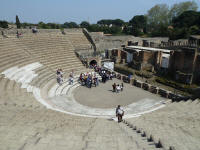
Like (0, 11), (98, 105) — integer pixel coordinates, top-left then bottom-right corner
(0, 31), (93, 106)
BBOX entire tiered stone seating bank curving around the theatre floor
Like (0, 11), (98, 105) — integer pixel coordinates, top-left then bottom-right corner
(0, 31), (200, 150)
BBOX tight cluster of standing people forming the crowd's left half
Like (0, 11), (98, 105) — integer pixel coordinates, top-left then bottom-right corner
(79, 72), (99, 88)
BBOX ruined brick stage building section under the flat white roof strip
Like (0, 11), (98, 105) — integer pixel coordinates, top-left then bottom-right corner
(124, 46), (172, 70)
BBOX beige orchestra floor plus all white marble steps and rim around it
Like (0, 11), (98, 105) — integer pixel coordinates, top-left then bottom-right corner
(1, 62), (165, 118)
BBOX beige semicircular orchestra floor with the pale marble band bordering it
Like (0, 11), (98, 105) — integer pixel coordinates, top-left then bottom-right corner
(48, 79), (166, 118)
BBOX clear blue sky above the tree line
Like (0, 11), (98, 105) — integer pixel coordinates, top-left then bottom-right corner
(0, 0), (200, 24)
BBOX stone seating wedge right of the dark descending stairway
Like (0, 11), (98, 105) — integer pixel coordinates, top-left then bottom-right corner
(126, 99), (200, 150)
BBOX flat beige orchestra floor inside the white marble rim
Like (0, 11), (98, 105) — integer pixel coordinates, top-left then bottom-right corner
(74, 79), (164, 108)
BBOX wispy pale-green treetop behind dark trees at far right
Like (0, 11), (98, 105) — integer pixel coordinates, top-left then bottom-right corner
(169, 1), (198, 20)
